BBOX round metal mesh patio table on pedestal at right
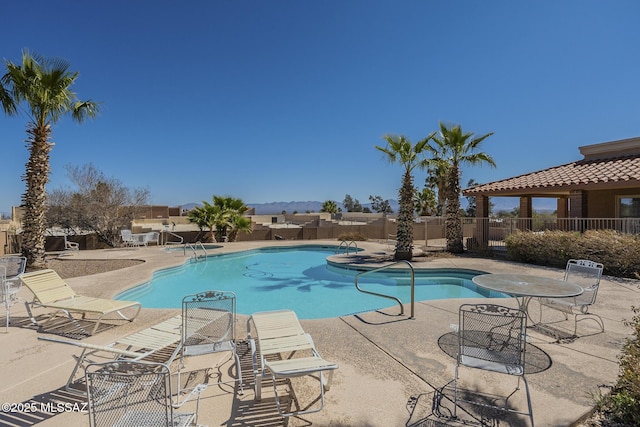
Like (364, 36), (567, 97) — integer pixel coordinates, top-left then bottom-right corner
(472, 273), (583, 318)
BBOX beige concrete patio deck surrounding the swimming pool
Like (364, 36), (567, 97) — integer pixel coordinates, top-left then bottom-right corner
(0, 241), (640, 427)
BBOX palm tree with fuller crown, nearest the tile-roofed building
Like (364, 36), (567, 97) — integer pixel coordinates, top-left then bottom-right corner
(427, 122), (496, 253)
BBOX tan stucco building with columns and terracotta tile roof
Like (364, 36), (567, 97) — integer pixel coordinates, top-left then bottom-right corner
(462, 137), (640, 247)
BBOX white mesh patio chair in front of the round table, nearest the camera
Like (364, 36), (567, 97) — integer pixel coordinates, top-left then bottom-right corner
(453, 304), (534, 426)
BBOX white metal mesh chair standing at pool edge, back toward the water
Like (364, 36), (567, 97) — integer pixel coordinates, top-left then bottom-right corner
(178, 291), (244, 394)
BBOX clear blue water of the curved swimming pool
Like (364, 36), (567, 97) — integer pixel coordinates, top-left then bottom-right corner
(117, 246), (502, 319)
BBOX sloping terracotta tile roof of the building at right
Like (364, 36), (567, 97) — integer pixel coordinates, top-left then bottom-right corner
(463, 154), (640, 196)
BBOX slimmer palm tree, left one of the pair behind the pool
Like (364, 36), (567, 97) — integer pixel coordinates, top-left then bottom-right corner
(375, 132), (435, 260)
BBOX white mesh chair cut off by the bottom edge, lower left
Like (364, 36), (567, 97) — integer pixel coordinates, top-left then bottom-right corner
(85, 361), (202, 427)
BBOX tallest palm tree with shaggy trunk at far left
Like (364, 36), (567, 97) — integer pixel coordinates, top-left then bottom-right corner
(0, 50), (98, 267)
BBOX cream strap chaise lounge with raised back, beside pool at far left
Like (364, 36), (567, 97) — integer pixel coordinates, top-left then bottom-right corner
(20, 269), (142, 335)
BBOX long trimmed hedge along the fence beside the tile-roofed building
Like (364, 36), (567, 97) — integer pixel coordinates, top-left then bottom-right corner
(505, 230), (640, 278)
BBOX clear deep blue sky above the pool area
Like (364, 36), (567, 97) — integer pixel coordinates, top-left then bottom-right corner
(0, 0), (640, 212)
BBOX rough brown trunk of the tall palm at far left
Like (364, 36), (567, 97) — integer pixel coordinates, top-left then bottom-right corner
(22, 123), (53, 268)
